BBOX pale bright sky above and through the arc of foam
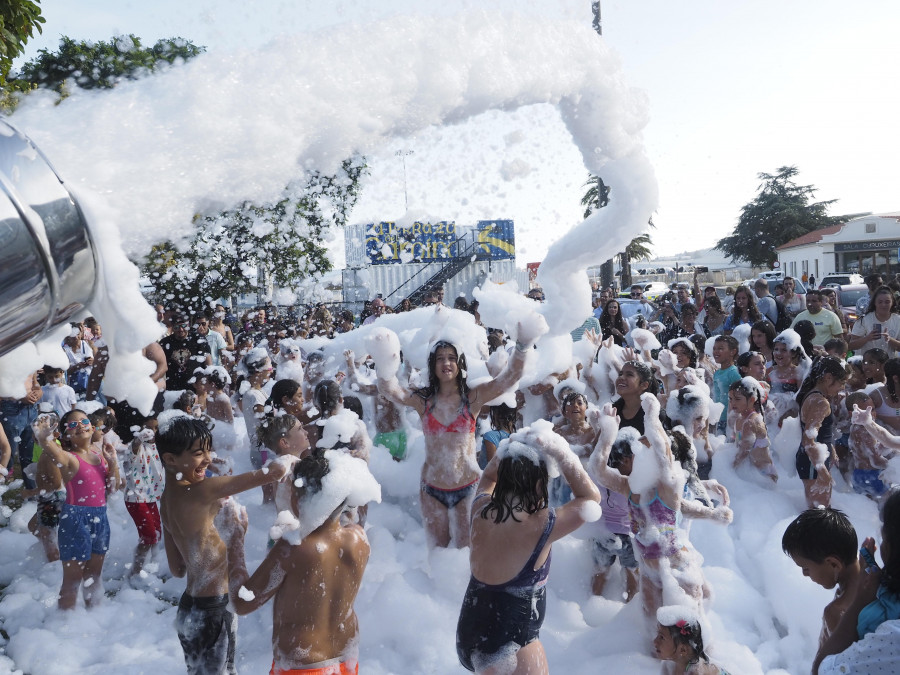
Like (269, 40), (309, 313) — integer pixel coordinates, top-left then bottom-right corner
(15, 0), (900, 265)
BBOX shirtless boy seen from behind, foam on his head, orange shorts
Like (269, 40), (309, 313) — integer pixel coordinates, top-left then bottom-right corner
(220, 453), (369, 675)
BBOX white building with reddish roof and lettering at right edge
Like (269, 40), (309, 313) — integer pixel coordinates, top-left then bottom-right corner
(776, 212), (900, 279)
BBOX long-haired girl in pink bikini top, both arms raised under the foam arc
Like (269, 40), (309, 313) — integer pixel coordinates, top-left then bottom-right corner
(371, 325), (538, 548)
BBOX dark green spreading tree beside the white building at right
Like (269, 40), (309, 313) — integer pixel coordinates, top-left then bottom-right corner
(716, 166), (841, 267)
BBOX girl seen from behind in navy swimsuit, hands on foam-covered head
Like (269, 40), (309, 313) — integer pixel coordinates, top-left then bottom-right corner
(456, 429), (600, 675)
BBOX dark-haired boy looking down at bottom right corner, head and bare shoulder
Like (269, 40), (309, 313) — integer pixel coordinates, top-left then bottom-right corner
(781, 507), (861, 647)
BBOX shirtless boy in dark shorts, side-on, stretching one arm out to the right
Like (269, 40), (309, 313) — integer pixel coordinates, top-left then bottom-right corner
(156, 412), (286, 675)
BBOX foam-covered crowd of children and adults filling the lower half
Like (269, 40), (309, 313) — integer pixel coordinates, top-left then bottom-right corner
(0, 278), (900, 674)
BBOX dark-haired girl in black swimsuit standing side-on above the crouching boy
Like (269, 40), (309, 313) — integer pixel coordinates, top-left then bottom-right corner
(796, 356), (847, 509)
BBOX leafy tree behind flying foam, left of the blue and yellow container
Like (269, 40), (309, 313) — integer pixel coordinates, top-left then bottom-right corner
(140, 157), (366, 310)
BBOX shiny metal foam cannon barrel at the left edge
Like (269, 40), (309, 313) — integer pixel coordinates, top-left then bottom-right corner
(0, 119), (98, 356)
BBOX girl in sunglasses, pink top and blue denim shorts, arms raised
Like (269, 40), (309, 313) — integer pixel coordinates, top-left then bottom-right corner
(34, 410), (119, 609)
